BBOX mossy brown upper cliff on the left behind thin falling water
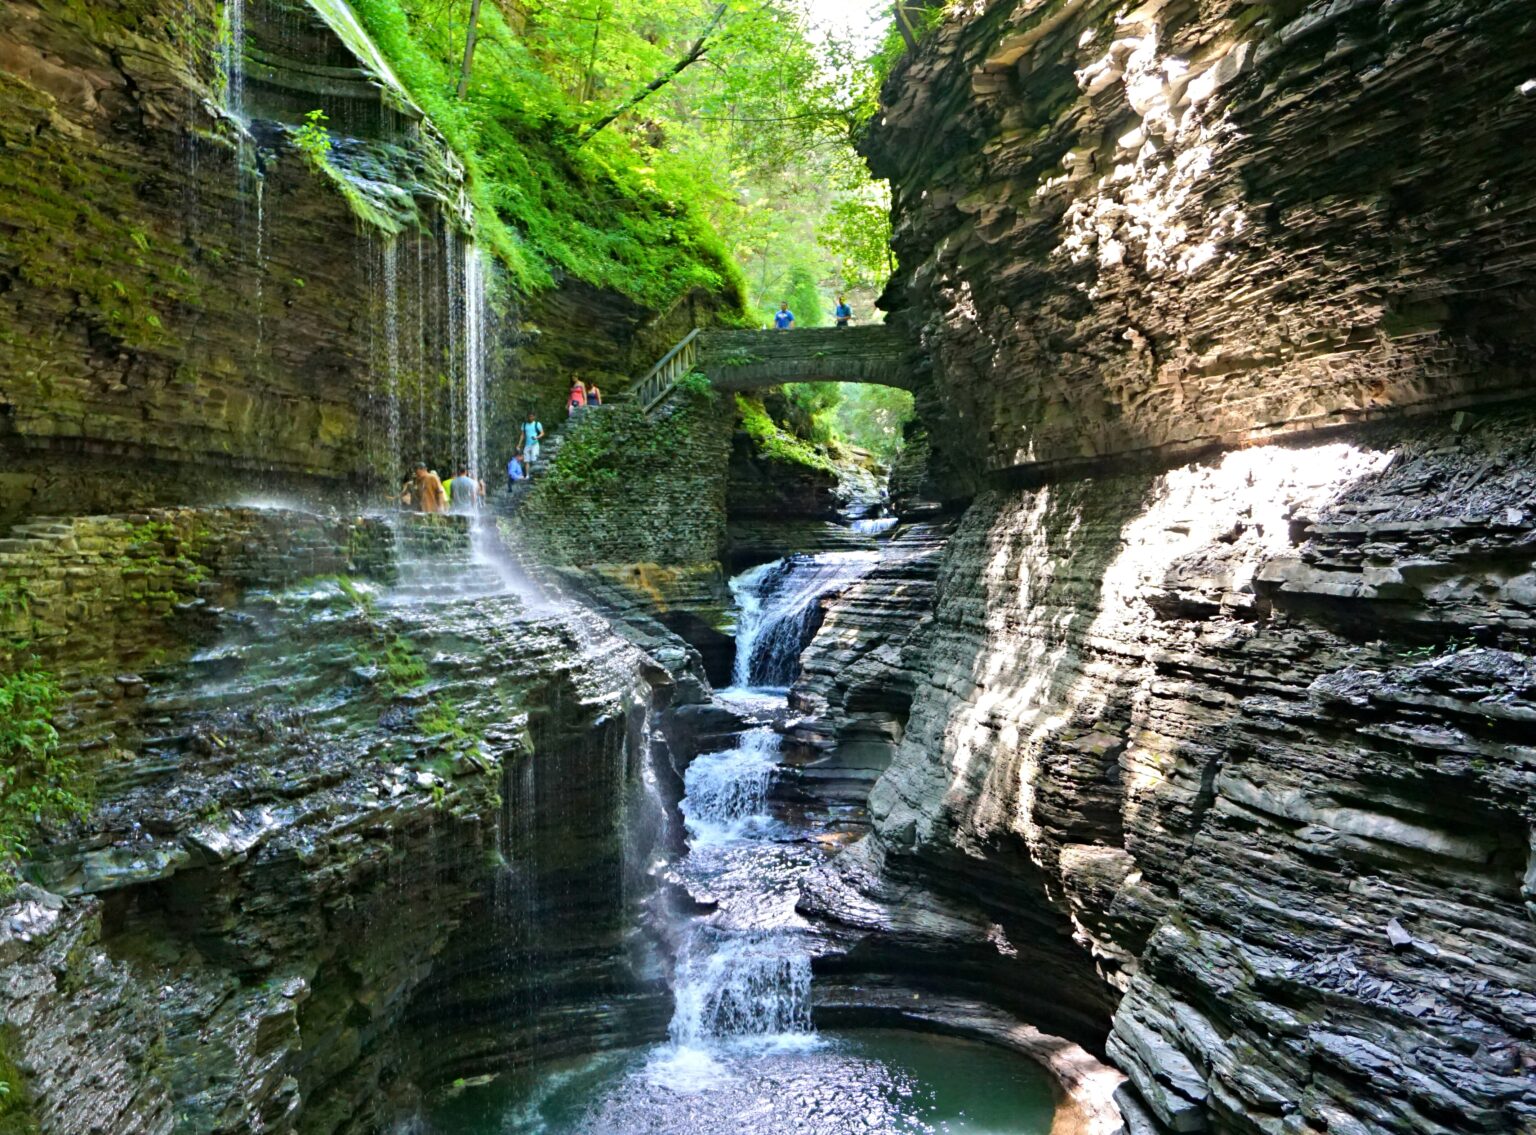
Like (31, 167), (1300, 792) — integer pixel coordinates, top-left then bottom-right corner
(0, 0), (719, 522)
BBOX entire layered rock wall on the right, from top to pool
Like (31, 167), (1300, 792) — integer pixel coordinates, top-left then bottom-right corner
(794, 0), (1536, 1135)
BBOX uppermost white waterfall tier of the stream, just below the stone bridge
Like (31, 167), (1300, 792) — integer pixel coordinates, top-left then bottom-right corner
(731, 551), (879, 688)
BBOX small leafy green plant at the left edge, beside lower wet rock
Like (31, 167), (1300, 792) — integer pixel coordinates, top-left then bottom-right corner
(0, 665), (89, 894)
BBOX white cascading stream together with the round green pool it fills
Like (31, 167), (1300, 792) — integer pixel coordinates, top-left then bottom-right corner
(430, 553), (1055, 1135)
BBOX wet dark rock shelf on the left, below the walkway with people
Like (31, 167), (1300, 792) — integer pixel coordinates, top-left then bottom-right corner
(0, 510), (671, 1132)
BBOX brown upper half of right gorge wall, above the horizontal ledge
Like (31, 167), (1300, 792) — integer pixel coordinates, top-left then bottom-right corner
(866, 0), (1536, 496)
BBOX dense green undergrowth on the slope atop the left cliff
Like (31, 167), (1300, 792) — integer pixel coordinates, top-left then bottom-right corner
(353, 0), (755, 307)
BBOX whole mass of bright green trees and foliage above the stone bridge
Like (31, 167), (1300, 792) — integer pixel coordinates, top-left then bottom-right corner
(353, 0), (892, 326)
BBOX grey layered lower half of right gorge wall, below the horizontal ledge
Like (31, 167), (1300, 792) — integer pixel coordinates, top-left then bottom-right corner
(805, 415), (1536, 1135)
